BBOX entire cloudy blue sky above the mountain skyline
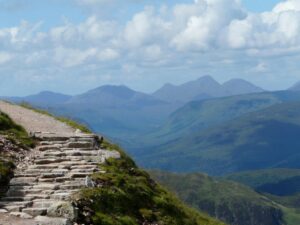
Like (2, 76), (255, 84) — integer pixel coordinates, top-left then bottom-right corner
(0, 0), (300, 96)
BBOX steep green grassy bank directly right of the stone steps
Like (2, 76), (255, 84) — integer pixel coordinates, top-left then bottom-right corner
(78, 146), (222, 225)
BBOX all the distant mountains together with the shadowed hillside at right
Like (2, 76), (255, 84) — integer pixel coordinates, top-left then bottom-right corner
(3, 76), (300, 175)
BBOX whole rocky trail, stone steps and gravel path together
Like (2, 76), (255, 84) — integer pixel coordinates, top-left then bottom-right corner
(0, 102), (120, 225)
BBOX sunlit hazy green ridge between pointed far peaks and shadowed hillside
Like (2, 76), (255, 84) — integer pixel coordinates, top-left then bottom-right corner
(131, 91), (300, 149)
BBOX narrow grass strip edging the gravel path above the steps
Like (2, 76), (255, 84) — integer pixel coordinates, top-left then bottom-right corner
(19, 102), (92, 133)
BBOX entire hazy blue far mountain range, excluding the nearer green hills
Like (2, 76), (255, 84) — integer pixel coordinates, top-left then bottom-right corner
(2, 76), (263, 140)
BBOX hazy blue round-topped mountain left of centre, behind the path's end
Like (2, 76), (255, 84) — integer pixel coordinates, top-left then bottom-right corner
(51, 85), (178, 140)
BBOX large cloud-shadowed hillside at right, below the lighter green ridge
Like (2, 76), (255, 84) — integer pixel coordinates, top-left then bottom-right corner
(137, 102), (300, 175)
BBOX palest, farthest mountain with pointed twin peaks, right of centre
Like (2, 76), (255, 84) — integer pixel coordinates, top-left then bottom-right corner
(153, 76), (263, 103)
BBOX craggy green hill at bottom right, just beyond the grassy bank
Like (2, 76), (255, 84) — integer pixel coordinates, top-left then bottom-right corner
(151, 171), (282, 225)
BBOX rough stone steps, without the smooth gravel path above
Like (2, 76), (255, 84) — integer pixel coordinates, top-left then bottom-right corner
(0, 133), (120, 222)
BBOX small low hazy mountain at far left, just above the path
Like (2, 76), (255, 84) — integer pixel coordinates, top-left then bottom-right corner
(3, 91), (72, 107)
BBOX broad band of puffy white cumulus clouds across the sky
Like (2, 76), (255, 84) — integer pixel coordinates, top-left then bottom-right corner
(0, 0), (300, 94)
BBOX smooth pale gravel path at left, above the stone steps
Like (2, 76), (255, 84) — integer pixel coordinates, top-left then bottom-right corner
(0, 101), (75, 134)
